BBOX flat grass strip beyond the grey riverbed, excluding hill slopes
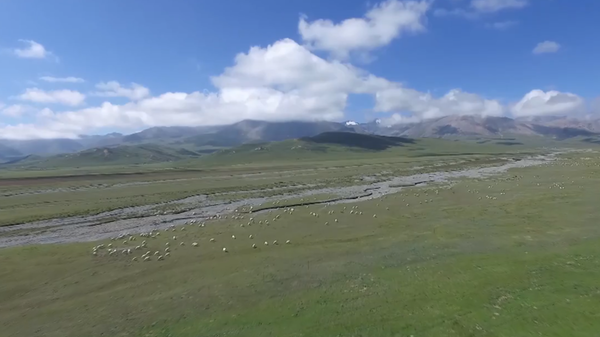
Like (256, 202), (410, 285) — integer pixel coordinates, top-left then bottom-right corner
(0, 140), (523, 226)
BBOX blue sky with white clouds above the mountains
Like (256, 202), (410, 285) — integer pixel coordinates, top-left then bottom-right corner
(0, 0), (600, 139)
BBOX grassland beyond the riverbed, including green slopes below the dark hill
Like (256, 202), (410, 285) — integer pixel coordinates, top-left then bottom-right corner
(0, 135), (534, 226)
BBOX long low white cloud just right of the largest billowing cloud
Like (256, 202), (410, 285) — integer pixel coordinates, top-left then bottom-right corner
(375, 86), (504, 121)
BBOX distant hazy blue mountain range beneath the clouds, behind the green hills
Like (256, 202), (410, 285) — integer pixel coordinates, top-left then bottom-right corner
(0, 115), (600, 162)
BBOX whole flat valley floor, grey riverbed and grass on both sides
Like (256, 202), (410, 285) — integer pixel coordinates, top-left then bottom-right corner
(0, 152), (600, 337)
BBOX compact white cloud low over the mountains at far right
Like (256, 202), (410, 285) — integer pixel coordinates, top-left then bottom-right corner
(511, 89), (585, 117)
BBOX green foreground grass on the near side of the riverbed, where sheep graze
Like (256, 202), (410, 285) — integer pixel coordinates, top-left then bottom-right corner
(0, 154), (600, 337)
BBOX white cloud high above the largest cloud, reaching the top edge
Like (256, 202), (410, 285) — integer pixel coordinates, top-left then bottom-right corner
(298, 0), (430, 58)
